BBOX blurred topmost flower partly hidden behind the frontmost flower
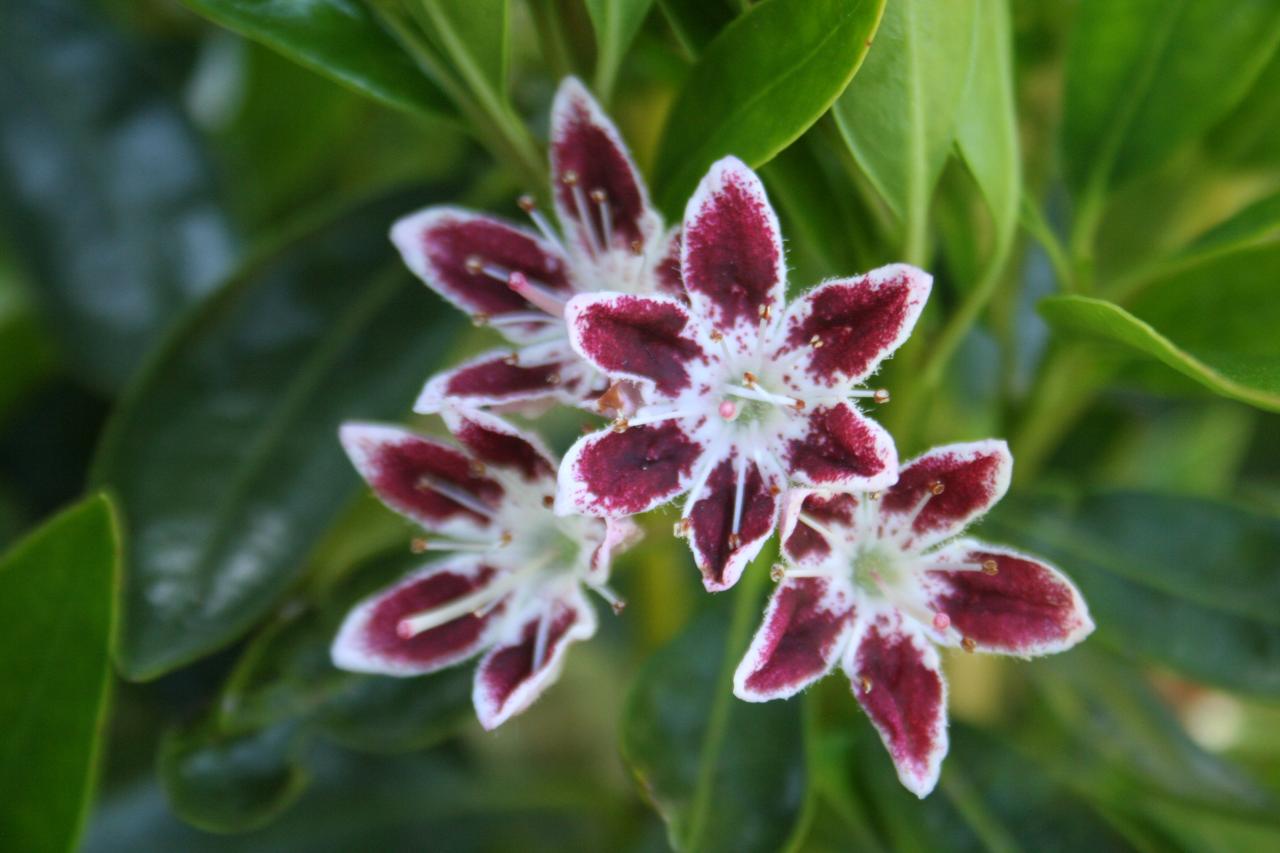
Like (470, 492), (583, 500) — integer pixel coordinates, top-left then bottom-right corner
(392, 77), (680, 412)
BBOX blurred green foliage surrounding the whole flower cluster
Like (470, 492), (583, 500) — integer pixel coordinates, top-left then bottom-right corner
(0, 0), (1280, 853)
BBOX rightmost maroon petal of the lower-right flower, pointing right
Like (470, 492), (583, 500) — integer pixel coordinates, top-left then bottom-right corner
(925, 539), (1093, 657)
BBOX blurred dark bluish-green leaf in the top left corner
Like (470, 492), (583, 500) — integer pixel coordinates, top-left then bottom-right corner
(0, 0), (234, 392)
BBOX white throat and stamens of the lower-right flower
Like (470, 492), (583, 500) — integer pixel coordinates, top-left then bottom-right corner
(771, 480), (1000, 652)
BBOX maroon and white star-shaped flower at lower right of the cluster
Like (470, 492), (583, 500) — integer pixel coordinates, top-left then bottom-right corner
(733, 441), (1093, 797)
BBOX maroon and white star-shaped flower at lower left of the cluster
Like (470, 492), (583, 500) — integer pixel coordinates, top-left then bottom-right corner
(332, 409), (637, 729)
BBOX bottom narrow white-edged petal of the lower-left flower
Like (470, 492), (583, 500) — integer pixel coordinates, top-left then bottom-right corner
(471, 589), (595, 729)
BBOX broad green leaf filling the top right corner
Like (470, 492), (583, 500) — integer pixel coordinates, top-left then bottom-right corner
(1062, 0), (1280, 193)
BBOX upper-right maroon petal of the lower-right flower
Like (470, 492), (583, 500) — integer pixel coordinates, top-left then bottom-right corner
(881, 439), (1014, 549)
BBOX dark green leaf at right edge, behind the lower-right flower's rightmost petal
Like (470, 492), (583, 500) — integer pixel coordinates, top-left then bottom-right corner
(980, 492), (1280, 697)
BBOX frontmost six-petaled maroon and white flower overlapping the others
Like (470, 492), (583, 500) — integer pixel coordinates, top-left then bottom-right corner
(557, 158), (932, 590)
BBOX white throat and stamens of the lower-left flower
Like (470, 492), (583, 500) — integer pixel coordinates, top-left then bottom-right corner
(396, 462), (626, 669)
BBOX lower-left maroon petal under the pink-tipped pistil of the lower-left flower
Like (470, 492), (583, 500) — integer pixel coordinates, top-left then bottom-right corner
(330, 557), (504, 675)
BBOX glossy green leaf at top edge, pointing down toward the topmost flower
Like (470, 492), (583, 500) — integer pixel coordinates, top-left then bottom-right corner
(183, 0), (456, 118)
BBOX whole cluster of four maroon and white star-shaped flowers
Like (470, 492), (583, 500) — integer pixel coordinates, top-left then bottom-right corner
(333, 79), (1093, 797)
